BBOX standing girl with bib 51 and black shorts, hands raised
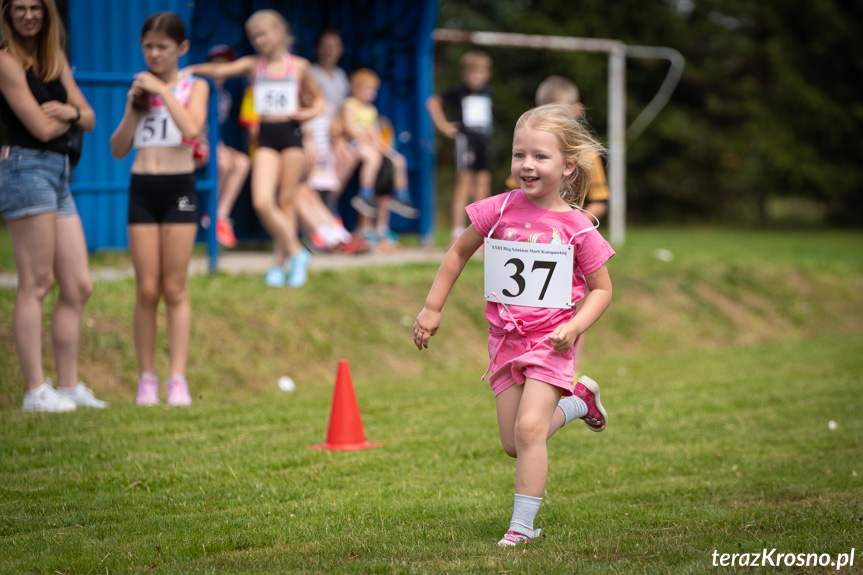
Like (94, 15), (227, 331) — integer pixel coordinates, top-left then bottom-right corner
(111, 12), (210, 406)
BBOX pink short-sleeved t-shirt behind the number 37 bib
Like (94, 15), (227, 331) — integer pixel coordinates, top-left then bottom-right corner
(466, 190), (614, 333)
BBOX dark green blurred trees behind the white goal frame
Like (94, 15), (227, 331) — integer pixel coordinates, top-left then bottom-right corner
(436, 0), (863, 230)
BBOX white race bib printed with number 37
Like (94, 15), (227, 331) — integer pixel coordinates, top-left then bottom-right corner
(483, 238), (574, 309)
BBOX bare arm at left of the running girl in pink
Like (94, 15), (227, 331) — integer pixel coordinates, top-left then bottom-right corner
(414, 226), (482, 350)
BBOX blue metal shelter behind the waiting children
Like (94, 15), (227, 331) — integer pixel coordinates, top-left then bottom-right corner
(68, 0), (438, 268)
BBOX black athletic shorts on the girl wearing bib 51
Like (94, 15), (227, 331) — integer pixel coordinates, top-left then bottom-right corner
(128, 174), (198, 224)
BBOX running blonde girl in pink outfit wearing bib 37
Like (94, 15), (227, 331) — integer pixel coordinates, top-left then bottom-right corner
(413, 105), (614, 546)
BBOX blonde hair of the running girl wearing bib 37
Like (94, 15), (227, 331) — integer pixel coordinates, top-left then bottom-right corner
(514, 104), (605, 207)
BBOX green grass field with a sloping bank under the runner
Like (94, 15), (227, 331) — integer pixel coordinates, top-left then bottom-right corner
(0, 229), (863, 574)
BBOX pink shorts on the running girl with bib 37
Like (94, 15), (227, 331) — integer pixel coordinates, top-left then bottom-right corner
(488, 331), (578, 396)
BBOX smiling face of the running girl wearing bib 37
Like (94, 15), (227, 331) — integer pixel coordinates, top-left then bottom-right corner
(512, 127), (575, 211)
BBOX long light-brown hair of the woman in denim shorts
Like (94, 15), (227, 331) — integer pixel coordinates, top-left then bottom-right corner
(0, 0), (66, 82)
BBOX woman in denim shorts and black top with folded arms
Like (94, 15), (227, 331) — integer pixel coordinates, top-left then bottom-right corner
(0, 0), (105, 411)
